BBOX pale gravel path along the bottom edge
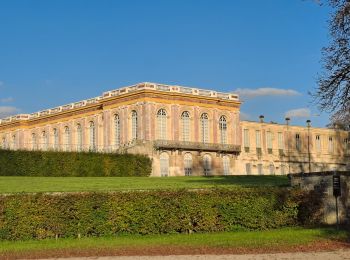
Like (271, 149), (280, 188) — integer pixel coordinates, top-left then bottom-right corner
(47, 249), (350, 260)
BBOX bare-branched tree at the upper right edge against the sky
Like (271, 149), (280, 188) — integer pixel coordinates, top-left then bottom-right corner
(313, 0), (350, 129)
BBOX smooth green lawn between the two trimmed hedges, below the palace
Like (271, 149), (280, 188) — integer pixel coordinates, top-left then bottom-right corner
(0, 176), (288, 193)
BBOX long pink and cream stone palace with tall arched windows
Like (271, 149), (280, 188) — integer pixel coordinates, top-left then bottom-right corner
(0, 82), (350, 176)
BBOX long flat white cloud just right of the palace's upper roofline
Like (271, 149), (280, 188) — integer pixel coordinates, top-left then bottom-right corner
(233, 88), (301, 98)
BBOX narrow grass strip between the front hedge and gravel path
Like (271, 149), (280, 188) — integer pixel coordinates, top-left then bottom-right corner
(0, 228), (347, 256)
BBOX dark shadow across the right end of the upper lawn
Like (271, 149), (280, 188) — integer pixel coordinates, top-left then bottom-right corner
(186, 175), (289, 187)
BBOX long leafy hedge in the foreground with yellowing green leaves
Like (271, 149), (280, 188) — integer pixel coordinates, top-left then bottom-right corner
(0, 187), (312, 240)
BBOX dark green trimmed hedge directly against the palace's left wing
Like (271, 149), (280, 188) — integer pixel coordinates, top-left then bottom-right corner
(0, 150), (152, 177)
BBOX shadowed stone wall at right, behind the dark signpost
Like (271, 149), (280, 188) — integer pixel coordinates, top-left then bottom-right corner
(290, 171), (350, 226)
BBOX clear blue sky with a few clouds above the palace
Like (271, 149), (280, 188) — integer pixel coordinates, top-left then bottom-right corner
(0, 0), (330, 127)
